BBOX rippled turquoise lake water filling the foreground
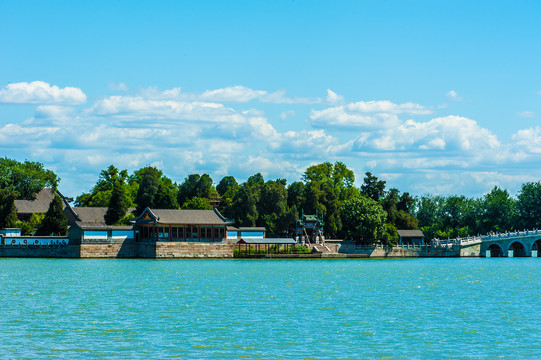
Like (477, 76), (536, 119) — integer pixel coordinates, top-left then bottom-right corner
(0, 258), (541, 359)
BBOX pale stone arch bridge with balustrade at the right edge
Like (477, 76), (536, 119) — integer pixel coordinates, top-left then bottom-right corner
(436, 229), (541, 257)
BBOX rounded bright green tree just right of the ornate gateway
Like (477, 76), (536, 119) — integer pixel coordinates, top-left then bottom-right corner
(341, 195), (387, 243)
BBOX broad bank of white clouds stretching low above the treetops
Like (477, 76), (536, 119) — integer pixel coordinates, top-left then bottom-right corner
(8, 83), (541, 196)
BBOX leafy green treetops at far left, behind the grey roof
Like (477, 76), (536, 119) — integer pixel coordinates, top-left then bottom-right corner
(0, 157), (60, 200)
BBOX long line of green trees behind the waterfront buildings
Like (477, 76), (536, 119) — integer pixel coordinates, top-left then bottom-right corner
(0, 158), (541, 244)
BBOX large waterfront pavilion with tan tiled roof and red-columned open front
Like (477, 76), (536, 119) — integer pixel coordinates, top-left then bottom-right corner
(132, 208), (232, 242)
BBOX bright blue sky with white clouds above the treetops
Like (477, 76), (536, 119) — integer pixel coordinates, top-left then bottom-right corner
(0, 0), (541, 196)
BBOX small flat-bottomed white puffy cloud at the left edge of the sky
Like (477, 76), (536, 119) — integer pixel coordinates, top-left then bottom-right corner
(0, 81), (86, 105)
